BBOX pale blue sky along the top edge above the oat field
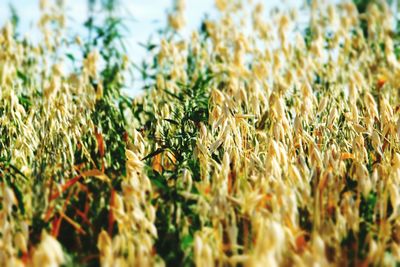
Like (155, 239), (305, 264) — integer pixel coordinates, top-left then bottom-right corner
(0, 0), (310, 60)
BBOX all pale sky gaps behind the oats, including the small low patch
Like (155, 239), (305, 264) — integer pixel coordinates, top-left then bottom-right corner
(0, 0), (398, 95)
